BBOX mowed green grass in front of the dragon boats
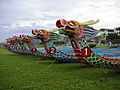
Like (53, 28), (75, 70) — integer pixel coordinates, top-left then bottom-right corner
(0, 49), (120, 90)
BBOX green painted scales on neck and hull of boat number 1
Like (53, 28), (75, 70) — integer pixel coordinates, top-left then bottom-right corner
(78, 38), (120, 69)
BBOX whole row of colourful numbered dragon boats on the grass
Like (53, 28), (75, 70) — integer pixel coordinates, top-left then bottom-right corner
(1, 19), (120, 70)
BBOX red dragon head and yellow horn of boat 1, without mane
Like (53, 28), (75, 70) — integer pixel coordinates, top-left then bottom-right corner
(56, 19), (99, 38)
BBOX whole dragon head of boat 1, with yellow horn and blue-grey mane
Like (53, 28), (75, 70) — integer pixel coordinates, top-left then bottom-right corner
(56, 19), (99, 38)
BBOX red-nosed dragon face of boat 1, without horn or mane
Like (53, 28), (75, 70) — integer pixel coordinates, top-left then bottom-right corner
(56, 19), (83, 38)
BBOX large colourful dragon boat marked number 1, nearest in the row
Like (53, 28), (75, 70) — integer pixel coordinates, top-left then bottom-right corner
(56, 19), (120, 70)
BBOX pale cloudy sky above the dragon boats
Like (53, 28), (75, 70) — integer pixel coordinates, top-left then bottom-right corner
(0, 0), (120, 42)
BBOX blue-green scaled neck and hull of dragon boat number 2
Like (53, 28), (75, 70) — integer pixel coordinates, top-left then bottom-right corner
(45, 33), (80, 62)
